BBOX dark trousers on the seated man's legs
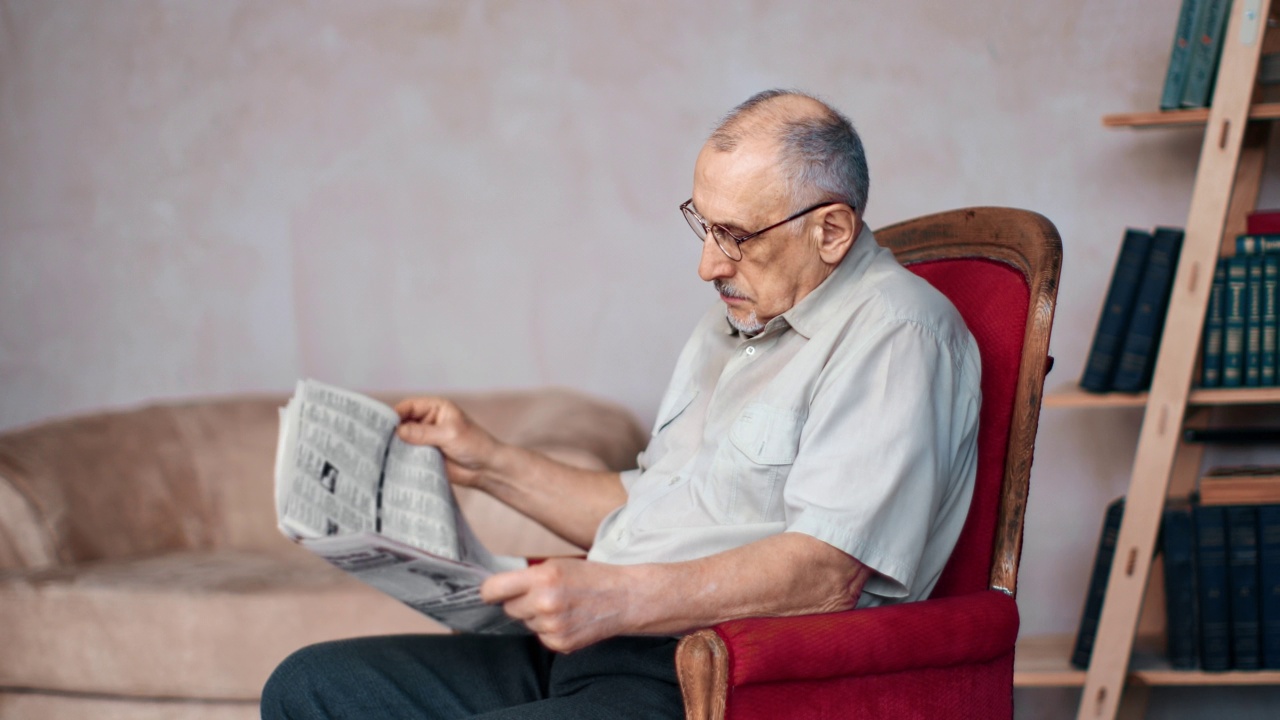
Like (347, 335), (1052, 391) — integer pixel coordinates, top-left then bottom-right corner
(254, 635), (684, 720)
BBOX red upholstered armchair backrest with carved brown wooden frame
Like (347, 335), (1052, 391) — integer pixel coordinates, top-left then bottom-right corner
(876, 208), (1062, 597)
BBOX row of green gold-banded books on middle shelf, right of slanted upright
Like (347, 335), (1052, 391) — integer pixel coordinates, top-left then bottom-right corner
(1199, 234), (1280, 387)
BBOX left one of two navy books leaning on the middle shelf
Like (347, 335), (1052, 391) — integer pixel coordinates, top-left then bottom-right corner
(1080, 228), (1152, 392)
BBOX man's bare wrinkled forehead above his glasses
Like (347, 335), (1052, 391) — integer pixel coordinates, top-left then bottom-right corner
(694, 135), (790, 222)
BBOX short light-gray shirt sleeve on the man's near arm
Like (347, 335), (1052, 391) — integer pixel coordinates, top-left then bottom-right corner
(783, 315), (980, 598)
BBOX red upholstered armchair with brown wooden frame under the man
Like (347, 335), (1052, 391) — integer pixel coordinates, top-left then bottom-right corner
(676, 208), (1062, 720)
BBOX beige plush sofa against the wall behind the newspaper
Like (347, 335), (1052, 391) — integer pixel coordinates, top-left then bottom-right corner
(0, 391), (648, 720)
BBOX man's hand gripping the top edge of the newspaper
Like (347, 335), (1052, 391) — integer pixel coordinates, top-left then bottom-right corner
(396, 397), (502, 487)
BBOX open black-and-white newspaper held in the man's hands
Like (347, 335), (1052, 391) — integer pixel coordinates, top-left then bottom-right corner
(275, 380), (527, 633)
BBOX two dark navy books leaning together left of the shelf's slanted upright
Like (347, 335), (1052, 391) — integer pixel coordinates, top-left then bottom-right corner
(1080, 227), (1183, 392)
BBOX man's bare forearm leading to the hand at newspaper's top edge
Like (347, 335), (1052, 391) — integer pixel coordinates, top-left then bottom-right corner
(476, 445), (627, 548)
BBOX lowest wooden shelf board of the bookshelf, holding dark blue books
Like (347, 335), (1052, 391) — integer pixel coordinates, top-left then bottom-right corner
(1014, 635), (1280, 688)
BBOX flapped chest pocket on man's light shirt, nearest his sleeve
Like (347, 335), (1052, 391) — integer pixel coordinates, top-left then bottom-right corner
(707, 402), (804, 523)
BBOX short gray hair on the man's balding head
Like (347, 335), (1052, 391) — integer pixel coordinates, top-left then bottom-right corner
(708, 90), (870, 215)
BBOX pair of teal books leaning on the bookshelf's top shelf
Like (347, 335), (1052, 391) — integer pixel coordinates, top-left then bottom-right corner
(1160, 0), (1231, 110)
